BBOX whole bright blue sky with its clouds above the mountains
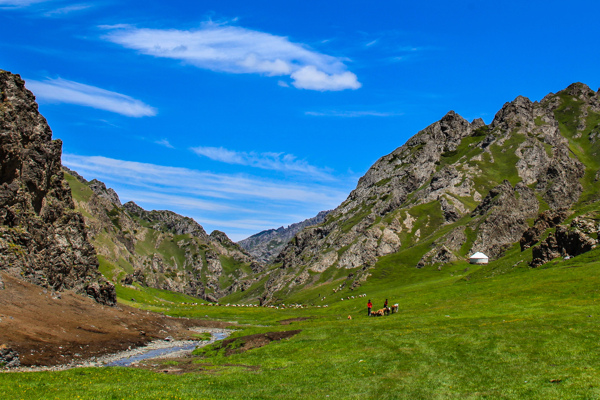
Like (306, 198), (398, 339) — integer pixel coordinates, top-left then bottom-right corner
(0, 0), (600, 240)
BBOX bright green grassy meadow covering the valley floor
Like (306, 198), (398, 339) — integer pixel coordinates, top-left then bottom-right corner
(0, 249), (600, 399)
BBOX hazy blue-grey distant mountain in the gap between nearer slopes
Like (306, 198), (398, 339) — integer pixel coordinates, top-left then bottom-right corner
(237, 210), (331, 264)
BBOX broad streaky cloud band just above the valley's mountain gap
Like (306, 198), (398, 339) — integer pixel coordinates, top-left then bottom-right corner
(62, 153), (356, 240)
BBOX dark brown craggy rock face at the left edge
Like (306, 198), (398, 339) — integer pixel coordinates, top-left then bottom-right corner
(0, 71), (116, 304)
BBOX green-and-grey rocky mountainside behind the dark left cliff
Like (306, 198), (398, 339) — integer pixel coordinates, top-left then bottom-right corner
(65, 170), (263, 301)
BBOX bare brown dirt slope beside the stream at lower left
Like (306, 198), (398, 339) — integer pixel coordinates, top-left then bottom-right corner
(0, 273), (230, 366)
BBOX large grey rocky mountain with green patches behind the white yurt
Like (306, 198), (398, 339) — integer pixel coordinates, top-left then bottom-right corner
(264, 83), (600, 301)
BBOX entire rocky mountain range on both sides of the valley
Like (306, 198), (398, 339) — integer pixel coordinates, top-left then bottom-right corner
(0, 68), (600, 304)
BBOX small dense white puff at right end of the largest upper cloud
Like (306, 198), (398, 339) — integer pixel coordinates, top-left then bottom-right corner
(291, 65), (362, 92)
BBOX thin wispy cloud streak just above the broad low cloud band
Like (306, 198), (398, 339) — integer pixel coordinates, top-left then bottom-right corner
(191, 147), (333, 180)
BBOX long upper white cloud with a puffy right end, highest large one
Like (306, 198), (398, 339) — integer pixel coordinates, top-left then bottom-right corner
(102, 22), (361, 91)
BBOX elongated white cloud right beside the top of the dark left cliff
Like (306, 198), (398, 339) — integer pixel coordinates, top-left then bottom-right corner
(26, 78), (157, 117)
